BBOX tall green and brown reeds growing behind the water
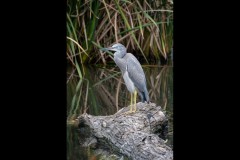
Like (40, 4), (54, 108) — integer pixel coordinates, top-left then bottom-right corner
(66, 0), (173, 70)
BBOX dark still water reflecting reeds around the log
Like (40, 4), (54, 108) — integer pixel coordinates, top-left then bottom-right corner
(67, 65), (173, 160)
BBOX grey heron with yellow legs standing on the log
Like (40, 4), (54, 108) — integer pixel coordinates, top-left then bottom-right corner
(102, 43), (149, 113)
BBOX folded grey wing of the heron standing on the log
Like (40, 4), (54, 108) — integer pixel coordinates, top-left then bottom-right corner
(124, 53), (146, 92)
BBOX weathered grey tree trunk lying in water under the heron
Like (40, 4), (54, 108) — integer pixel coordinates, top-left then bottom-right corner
(79, 102), (173, 160)
